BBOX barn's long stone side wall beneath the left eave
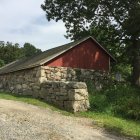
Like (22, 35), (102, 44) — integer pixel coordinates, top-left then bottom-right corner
(0, 67), (41, 95)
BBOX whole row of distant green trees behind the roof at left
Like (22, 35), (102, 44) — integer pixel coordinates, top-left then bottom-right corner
(0, 41), (41, 66)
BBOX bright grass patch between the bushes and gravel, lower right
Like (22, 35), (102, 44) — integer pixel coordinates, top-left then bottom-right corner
(79, 111), (140, 139)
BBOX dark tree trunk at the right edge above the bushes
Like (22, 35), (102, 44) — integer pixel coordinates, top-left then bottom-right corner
(132, 40), (140, 87)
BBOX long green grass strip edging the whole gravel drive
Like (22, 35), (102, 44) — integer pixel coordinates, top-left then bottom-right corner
(0, 93), (140, 139)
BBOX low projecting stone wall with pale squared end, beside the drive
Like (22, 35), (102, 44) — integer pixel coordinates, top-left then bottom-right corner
(36, 82), (89, 112)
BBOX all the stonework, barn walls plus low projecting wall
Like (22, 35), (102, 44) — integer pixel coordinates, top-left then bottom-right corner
(0, 66), (108, 112)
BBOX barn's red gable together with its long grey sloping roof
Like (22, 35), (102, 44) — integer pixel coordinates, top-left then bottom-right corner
(0, 37), (115, 74)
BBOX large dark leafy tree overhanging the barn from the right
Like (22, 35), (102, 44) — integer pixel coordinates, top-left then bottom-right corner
(41, 0), (140, 86)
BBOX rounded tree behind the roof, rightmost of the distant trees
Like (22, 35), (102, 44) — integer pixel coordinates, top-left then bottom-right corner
(23, 43), (41, 57)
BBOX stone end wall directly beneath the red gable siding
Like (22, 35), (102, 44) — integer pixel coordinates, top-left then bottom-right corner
(41, 66), (110, 89)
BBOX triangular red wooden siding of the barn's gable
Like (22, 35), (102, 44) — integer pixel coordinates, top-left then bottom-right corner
(45, 39), (110, 71)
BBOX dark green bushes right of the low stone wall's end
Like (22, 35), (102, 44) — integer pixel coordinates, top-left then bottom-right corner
(88, 83), (140, 120)
